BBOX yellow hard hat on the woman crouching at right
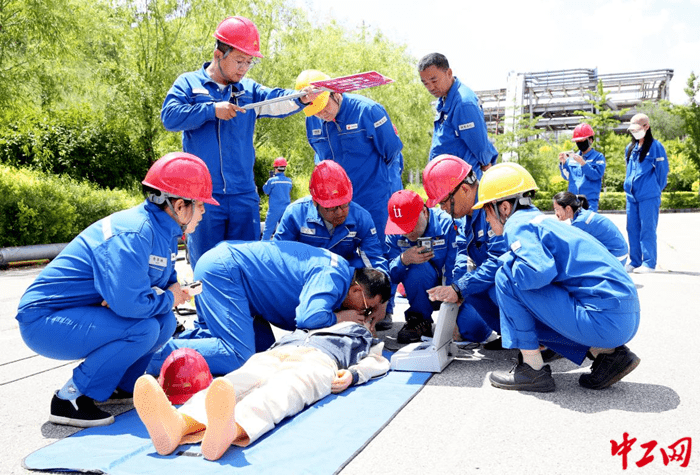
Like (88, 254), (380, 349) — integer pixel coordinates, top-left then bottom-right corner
(472, 162), (538, 209)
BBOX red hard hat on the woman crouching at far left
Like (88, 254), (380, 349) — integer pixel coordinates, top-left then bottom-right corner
(141, 152), (219, 205)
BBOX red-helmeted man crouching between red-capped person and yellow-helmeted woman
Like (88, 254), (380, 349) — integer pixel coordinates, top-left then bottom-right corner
(423, 155), (505, 349)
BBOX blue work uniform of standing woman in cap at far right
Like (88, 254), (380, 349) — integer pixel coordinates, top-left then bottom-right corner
(624, 140), (668, 269)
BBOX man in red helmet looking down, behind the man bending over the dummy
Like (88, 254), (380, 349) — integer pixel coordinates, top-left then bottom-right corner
(275, 160), (388, 273)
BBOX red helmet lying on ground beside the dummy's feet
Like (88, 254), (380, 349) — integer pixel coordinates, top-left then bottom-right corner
(158, 348), (214, 404)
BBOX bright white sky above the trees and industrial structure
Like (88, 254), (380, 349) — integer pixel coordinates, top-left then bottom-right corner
(295, 0), (700, 104)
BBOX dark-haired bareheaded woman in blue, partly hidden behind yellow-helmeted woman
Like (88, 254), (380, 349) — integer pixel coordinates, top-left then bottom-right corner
(552, 191), (629, 265)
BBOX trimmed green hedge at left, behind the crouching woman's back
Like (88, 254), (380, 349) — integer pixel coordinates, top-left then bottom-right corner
(0, 165), (142, 247)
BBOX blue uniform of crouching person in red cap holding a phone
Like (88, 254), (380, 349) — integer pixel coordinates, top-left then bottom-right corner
(386, 208), (457, 321)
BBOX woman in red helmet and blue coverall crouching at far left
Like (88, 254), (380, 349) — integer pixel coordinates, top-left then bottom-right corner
(16, 152), (217, 427)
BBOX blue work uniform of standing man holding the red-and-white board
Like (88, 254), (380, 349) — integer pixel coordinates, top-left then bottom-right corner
(160, 63), (304, 267)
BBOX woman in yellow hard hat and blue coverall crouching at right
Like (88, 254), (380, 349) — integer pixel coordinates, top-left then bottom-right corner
(474, 163), (640, 392)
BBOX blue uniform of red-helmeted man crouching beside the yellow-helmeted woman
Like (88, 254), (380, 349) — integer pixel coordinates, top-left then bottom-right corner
(454, 207), (506, 343)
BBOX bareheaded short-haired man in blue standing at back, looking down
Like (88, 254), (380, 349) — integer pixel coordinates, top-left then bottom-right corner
(418, 53), (498, 179)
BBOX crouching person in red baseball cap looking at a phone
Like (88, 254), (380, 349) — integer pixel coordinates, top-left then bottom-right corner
(377, 190), (457, 343)
